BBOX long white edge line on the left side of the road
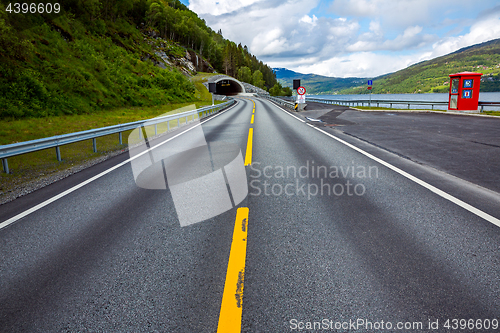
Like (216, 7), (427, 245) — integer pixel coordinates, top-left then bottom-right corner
(0, 102), (239, 229)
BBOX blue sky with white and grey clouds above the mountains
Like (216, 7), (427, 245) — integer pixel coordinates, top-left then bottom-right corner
(181, 0), (500, 77)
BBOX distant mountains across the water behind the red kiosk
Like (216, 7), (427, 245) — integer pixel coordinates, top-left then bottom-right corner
(273, 39), (500, 94)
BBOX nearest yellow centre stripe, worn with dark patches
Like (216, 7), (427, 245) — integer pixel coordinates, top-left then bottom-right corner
(217, 207), (249, 333)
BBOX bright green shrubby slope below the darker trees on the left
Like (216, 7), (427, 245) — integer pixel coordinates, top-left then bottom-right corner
(0, 11), (196, 119)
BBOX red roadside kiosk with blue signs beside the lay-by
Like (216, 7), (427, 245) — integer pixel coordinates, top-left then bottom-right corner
(448, 72), (483, 111)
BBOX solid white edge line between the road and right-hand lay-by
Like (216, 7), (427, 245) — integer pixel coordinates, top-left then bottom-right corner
(307, 124), (500, 227)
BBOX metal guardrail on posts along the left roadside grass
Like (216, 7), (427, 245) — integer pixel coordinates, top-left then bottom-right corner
(0, 100), (235, 173)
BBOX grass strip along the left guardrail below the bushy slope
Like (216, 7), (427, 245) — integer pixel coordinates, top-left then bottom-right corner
(0, 73), (220, 203)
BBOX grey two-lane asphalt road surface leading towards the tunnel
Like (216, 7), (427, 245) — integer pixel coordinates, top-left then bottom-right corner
(0, 98), (500, 332)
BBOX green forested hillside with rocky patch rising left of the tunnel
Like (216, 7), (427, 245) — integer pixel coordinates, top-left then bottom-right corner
(0, 0), (276, 118)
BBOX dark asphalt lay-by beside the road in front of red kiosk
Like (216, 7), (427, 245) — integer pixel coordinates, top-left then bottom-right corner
(312, 103), (500, 192)
